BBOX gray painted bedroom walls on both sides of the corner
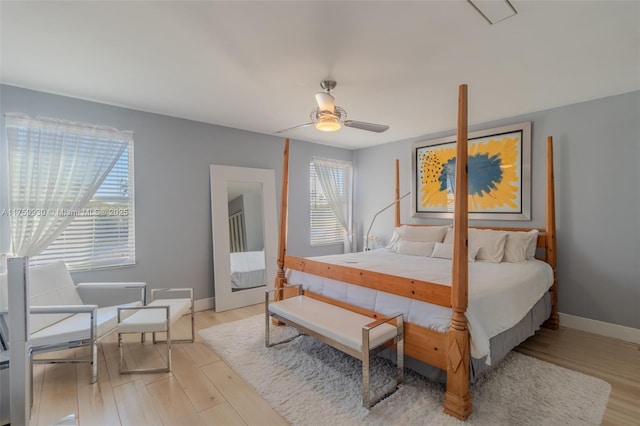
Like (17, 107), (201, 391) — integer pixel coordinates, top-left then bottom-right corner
(0, 86), (640, 328)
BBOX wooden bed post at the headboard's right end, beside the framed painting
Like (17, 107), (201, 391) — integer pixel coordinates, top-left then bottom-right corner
(543, 136), (560, 330)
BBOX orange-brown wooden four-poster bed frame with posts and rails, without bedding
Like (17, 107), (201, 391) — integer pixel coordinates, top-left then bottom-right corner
(275, 85), (559, 420)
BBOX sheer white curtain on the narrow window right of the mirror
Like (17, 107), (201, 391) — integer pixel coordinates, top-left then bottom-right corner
(313, 157), (353, 253)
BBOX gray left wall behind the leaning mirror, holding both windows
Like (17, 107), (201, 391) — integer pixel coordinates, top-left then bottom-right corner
(0, 85), (353, 299)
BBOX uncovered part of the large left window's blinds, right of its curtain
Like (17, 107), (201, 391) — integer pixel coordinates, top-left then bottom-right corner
(30, 141), (135, 270)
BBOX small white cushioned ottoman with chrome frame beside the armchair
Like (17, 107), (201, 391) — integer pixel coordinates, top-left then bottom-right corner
(117, 288), (195, 374)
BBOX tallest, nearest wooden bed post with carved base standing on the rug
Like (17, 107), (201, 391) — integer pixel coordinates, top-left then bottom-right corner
(444, 84), (471, 420)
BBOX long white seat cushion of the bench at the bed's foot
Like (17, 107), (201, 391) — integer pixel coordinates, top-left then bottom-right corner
(269, 296), (397, 352)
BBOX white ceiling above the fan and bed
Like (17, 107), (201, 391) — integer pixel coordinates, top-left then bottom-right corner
(0, 0), (640, 149)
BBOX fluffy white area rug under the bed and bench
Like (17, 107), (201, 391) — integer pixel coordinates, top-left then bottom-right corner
(200, 315), (611, 426)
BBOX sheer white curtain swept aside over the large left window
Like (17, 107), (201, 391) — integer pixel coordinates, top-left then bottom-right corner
(5, 114), (133, 256)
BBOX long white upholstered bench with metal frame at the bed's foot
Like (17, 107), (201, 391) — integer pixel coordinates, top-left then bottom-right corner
(265, 286), (404, 409)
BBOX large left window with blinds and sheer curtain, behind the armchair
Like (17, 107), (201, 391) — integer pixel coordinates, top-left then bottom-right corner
(0, 113), (135, 270)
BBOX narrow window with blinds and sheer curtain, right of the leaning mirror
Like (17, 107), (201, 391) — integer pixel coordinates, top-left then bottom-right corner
(309, 158), (353, 246)
